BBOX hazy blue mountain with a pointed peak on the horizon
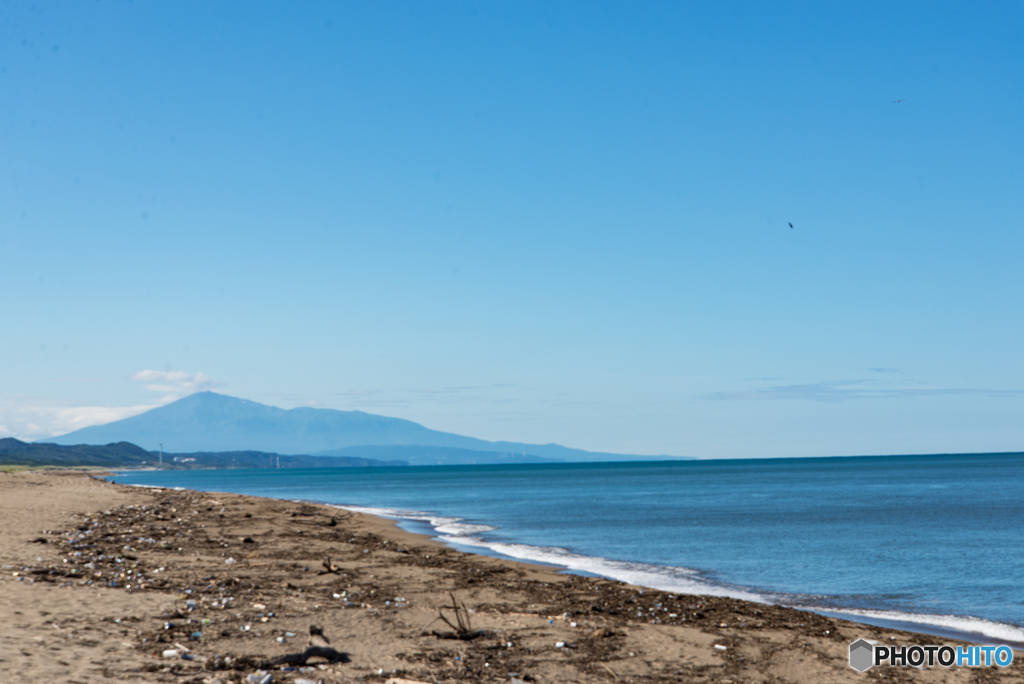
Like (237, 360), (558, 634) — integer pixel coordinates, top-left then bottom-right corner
(48, 392), (688, 462)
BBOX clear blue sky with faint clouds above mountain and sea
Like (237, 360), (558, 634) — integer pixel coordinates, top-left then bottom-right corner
(0, 0), (1024, 458)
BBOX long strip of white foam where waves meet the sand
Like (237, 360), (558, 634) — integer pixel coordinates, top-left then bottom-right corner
(338, 506), (1024, 644)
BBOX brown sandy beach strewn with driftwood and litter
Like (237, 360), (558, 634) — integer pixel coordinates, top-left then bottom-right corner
(0, 471), (1024, 684)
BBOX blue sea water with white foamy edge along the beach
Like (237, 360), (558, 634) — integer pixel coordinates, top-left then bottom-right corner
(117, 454), (1024, 644)
